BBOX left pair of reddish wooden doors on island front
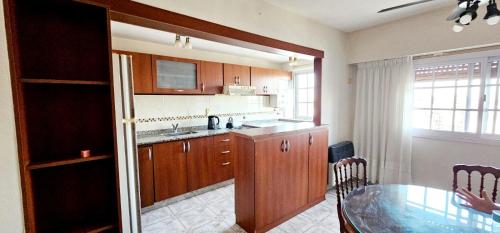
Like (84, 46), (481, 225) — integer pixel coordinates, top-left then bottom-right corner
(255, 133), (309, 228)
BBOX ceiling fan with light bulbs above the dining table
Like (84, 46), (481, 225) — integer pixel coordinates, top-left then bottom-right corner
(377, 0), (500, 32)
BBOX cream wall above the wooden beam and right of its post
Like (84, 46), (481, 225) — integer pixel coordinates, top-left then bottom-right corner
(133, 0), (353, 143)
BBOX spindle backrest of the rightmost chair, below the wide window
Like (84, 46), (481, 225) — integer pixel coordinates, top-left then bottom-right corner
(453, 164), (500, 202)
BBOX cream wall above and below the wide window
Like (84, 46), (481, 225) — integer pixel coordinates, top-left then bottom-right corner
(348, 8), (500, 189)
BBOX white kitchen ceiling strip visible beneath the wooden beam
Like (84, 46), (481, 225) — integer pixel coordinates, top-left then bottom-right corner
(111, 21), (312, 63)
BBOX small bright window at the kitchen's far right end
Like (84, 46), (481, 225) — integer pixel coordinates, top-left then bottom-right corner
(295, 71), (314, 120)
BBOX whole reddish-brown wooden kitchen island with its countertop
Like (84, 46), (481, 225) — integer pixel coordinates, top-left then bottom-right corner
(233, 123), (328, 232)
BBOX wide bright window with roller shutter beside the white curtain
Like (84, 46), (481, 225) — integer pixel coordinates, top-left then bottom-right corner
(413, 53), (500, 140)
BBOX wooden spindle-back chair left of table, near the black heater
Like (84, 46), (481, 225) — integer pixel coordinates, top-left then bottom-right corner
(333, 158), (369, 233)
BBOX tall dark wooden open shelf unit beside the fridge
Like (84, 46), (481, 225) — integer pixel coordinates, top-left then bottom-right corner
(4, 0), (121, 232)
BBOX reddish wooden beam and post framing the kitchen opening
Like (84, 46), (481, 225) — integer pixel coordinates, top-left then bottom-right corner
(77, 0), (324, 124)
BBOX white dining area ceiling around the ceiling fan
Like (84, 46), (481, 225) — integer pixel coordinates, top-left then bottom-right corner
(264, 0), (457, 32)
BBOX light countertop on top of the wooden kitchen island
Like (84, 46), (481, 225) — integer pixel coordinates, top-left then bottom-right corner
(232, 122), (327, 140)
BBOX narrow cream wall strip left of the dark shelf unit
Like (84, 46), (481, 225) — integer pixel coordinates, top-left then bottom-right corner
(0, 0), (24, 233)
